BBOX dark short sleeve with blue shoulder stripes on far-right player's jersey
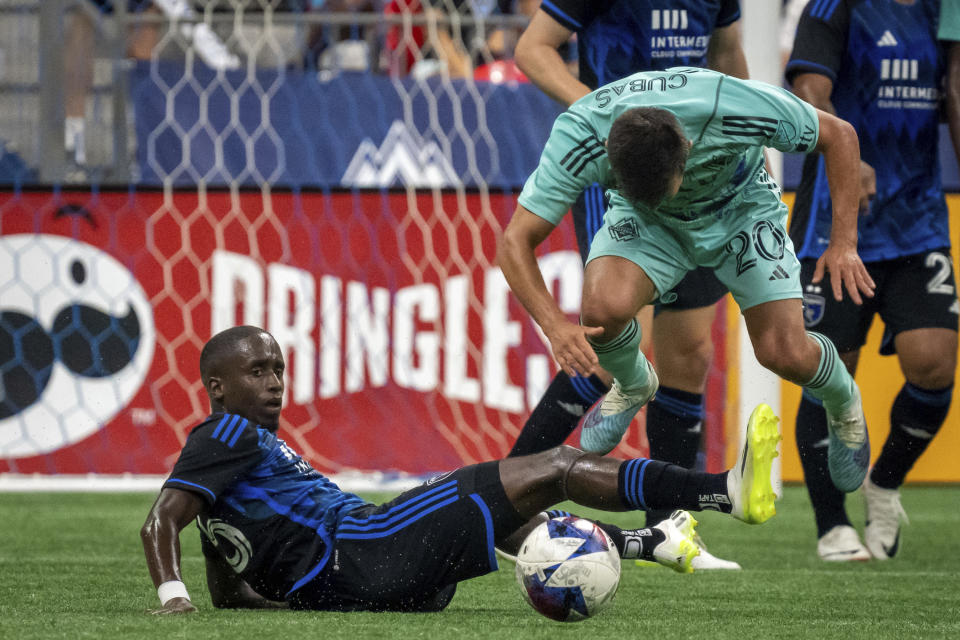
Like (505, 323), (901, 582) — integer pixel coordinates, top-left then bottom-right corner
(784, 0), (850, 82)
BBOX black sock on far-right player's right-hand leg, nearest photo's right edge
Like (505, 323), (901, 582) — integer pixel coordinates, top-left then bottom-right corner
(870, 382), (953, 489)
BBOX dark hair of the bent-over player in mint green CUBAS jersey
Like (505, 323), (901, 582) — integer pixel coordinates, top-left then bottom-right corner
(607, 107), (690, 207)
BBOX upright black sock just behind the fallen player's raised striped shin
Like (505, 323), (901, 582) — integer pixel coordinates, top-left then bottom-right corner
(647, 387), (703, 526)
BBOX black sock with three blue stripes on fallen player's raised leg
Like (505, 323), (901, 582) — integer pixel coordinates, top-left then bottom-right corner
(618, 458), (731, 513)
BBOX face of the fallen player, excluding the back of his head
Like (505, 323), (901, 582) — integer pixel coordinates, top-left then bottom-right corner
(219, 333), (284, 428)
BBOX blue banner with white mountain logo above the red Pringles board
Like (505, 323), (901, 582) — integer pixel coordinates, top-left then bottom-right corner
(131, 62), (561, 188)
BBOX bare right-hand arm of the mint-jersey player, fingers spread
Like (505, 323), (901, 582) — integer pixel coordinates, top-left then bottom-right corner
(813, 109), (875, 304)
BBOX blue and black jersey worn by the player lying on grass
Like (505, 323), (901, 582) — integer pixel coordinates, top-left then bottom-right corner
(163, 414), (367, 600)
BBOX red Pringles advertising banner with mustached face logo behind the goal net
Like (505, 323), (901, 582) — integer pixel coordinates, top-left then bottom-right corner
(0, 190), (722, 474)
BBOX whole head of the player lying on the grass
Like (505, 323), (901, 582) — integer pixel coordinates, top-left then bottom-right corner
(200, 326), (284, 429)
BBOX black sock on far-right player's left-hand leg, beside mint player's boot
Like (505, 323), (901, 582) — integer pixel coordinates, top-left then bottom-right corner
(796, 391), (850, 538)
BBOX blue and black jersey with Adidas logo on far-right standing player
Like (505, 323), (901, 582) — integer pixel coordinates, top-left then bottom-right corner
(786, 0), (950, 262)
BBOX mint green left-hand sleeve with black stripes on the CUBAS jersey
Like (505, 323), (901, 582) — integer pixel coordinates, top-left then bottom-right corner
(517, 111), (609, 225)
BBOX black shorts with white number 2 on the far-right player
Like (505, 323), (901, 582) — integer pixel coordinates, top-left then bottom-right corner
(800, 249), (960, 355)
